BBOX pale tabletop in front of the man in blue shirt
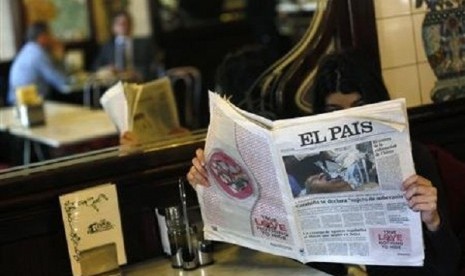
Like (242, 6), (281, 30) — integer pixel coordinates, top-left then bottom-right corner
(0, 101), (118, 164)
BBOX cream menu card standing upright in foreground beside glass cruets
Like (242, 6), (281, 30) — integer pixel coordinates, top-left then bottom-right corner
(60, 184), (126, 276)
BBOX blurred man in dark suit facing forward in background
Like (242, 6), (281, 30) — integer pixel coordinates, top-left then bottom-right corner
(94, 11), (156, 81)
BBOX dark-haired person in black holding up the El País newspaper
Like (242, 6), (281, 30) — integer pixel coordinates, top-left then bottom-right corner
(187, 53), (460, 275)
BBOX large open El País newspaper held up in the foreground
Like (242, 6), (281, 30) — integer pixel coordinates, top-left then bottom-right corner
(196, 92), (424, 266)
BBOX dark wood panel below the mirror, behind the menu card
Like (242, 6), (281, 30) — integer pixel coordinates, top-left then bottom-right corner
(0, 141), (203, 275)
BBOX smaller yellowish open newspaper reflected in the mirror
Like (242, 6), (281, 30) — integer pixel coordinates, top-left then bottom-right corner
(100, 77), (180, 143)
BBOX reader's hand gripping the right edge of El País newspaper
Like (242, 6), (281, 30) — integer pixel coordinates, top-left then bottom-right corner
(402, 174), (441, 232)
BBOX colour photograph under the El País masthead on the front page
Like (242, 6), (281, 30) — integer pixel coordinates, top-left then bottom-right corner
(283, 141), (379, 198)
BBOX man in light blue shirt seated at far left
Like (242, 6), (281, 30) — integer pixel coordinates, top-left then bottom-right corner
(7, 22), (71, 105)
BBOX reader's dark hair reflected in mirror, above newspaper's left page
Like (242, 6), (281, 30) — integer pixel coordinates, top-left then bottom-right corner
(215, 45), (274, 105)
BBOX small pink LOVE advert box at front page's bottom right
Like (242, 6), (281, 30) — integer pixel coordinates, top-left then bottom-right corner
(370, 228), (411, 253)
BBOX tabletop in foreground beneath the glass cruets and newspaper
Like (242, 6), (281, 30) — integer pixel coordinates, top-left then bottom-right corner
(122, 243), (329, 276)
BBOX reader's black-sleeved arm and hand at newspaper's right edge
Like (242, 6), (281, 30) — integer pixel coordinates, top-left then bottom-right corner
(367, 144), (460, 275)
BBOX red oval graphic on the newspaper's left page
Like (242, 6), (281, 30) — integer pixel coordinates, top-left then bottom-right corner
(208, 151), (253, 199)
